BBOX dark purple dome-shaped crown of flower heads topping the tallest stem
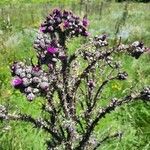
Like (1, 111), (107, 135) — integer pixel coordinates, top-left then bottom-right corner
(40, 9), (88, 36)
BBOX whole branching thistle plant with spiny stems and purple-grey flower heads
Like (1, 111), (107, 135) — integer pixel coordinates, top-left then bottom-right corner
(0, 9), (150, 150)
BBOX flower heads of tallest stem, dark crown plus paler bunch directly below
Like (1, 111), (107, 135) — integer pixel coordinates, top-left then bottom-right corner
(34, 9), (88, 64)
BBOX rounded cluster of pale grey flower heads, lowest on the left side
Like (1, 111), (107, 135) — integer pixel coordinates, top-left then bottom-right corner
(11, 62), (52, 101)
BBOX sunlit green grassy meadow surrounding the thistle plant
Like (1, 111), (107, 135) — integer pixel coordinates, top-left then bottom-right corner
(0, 0), (150, 150)
